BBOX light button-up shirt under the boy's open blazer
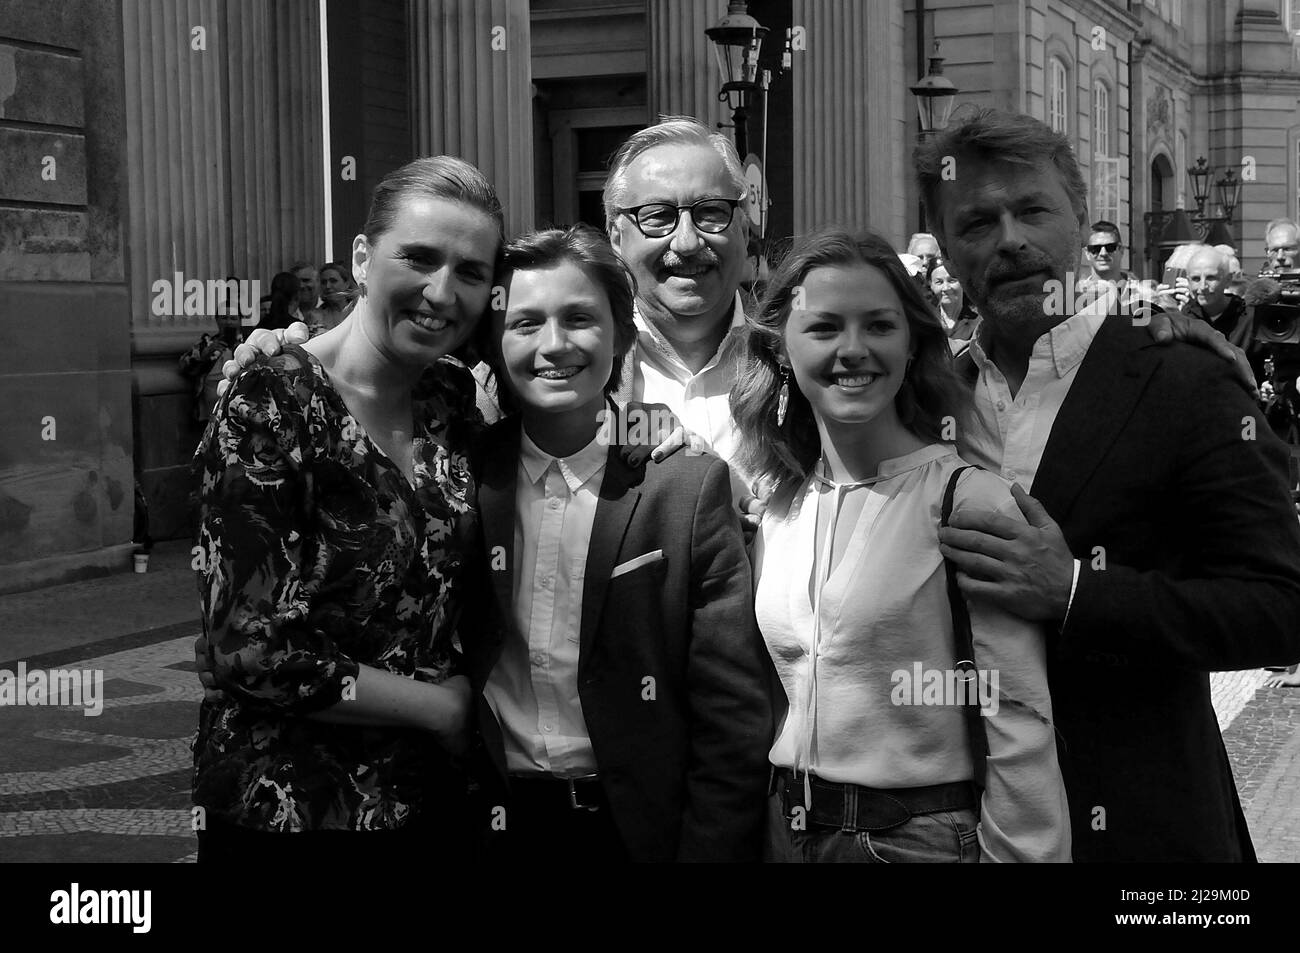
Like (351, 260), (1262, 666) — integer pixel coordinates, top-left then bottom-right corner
(484, 433), (608, 777)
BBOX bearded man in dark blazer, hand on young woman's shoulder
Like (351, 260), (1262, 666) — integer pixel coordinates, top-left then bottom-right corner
(917, 111), (1300, 862)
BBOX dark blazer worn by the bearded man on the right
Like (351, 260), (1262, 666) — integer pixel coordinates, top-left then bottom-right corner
(965, 315), (1300, 861)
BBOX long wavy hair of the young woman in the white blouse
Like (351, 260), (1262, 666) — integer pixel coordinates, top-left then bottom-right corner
(731, 228), (971, 515)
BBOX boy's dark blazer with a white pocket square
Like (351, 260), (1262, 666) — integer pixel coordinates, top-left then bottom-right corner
(465, 417), (774, 861)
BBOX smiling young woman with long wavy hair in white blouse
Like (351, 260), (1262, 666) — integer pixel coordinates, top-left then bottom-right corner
(732, 231), (1070, 863)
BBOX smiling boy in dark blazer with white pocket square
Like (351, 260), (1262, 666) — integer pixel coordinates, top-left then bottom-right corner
(464, 226), (772, 862)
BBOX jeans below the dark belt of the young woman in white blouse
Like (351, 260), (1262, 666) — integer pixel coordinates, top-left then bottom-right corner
(763, 793), (979, 863)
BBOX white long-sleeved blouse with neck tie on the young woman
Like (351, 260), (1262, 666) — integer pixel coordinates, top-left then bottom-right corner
(754, 445), (1070, 862)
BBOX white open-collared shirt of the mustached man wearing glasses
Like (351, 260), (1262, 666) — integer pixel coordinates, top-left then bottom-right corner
(629, 291), (745, 491)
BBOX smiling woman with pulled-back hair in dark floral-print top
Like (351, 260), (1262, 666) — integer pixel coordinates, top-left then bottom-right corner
(194, 156), (503, 863)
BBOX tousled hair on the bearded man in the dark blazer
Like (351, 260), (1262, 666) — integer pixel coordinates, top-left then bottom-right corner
(913, 108), (1088, 246)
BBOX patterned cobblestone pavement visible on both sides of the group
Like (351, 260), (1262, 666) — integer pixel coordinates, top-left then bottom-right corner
(0, 623), (1300, 862)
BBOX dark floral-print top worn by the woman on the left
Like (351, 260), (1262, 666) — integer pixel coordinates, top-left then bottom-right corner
(194, 347), (481, 832)
